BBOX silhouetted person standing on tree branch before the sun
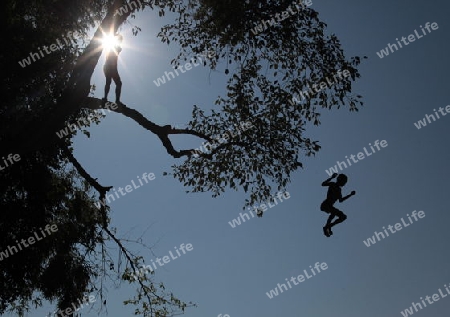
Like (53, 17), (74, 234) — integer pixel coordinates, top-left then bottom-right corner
(102, 34), (123, 104)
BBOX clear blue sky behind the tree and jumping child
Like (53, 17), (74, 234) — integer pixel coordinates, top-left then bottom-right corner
(15, 0), (450, 317)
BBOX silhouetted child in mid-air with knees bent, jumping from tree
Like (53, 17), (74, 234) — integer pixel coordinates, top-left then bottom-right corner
(320, 173), (356, 237)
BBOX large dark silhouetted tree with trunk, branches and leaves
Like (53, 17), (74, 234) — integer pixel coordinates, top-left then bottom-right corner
(0, 0), (362, 317)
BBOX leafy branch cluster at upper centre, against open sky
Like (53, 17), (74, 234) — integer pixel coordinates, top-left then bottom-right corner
(159, 0), (362, 208)
